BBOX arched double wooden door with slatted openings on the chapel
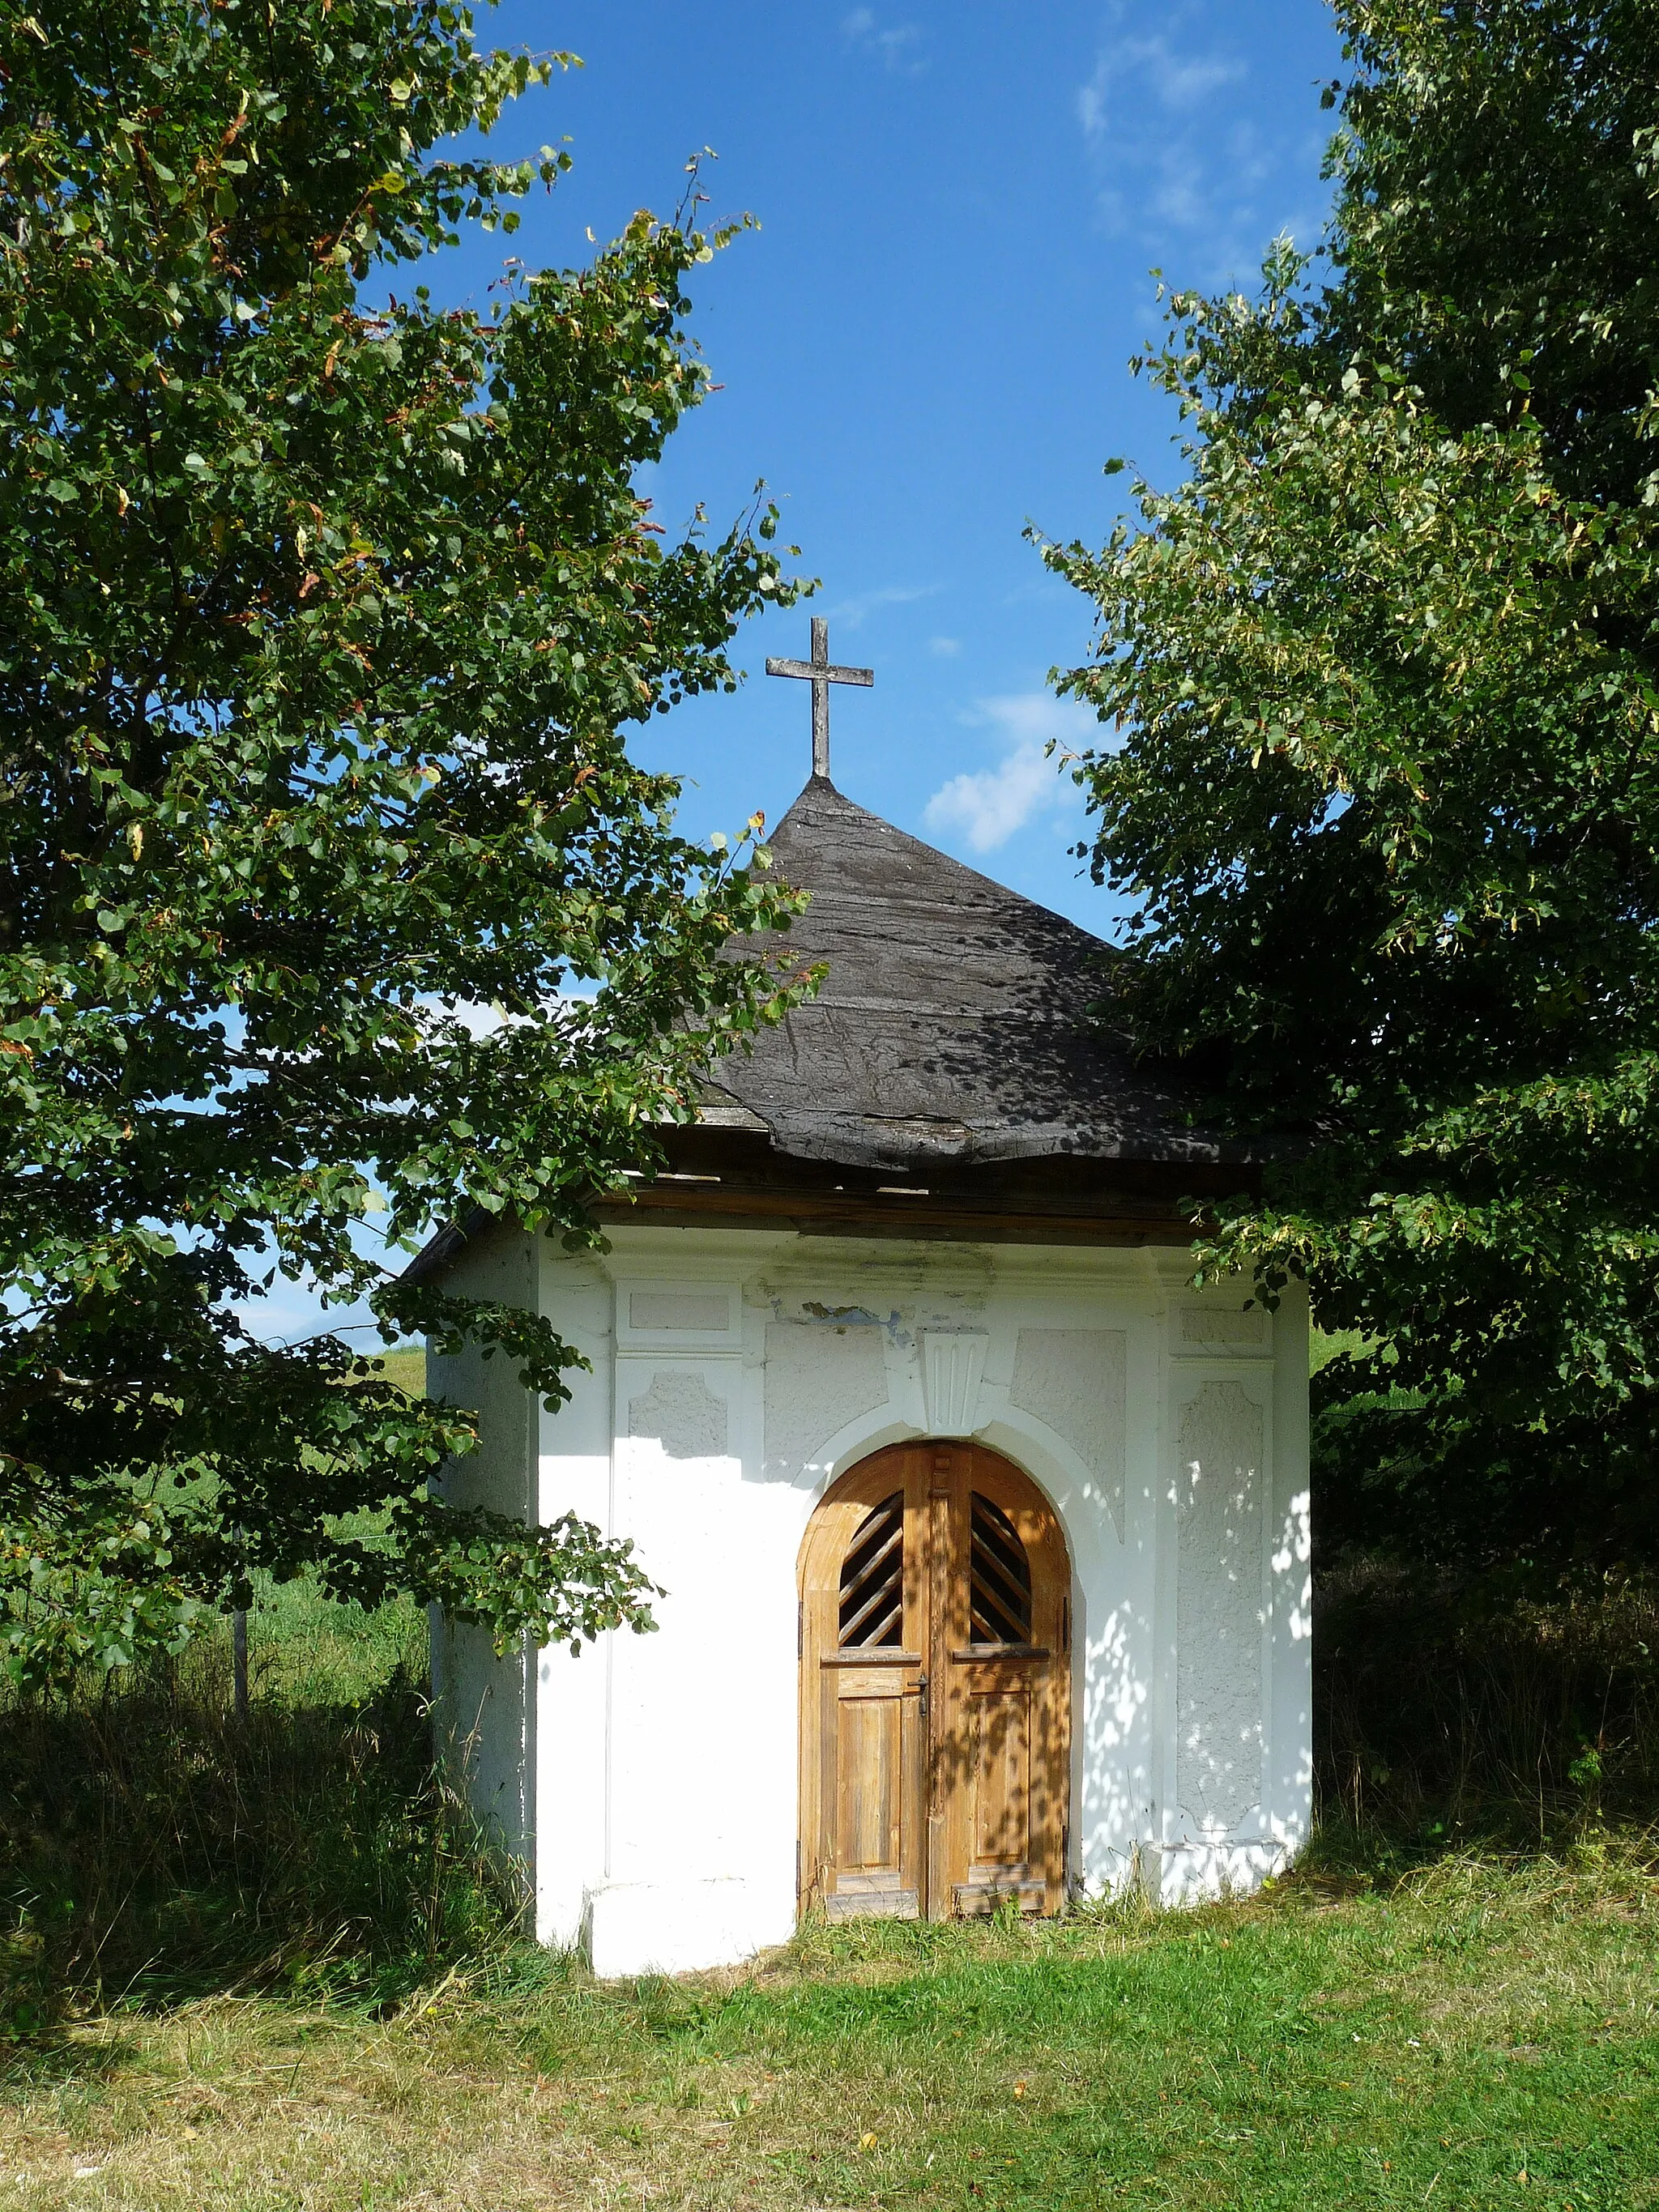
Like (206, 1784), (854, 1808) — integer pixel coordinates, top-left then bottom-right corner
(801, 1443), (1071, 1920)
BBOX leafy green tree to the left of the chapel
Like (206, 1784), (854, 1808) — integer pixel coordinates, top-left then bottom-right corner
(0, 0), (792, 1681)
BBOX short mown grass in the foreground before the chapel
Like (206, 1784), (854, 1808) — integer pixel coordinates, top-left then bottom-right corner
(0, 1852), (1659, 2212)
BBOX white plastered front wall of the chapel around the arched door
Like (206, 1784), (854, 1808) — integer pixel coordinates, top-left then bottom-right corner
(429, 1228), (1310, 1973)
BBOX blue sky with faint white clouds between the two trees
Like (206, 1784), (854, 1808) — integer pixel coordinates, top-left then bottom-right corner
(243, 0), (1341, 1336)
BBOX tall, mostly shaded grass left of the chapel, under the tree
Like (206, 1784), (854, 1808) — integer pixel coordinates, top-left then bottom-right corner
(0, 1588), (515, 2035)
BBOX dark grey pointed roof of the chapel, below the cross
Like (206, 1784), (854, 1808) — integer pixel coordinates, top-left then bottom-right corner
(706, 777), (1236, 1168)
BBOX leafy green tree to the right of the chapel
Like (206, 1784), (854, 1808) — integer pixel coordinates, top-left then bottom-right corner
(1047, 0), (1659, 1571)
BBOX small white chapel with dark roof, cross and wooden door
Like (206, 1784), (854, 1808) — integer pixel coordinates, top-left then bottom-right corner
(414, 621), (1311, 1975)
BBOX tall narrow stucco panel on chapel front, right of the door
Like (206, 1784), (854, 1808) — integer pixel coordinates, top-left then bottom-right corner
(1175, 1383), (1265, 1834)
